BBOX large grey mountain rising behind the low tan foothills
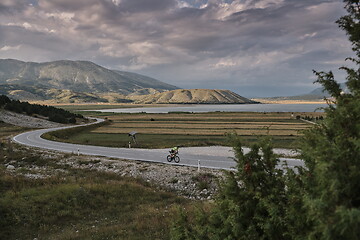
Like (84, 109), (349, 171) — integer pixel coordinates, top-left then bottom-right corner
(0, 59), (178, 95)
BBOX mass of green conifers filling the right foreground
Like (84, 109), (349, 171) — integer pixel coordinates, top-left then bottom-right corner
(172, 0), (360, 240)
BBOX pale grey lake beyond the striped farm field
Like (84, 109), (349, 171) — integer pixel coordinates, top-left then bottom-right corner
(97, 103), (327, 113)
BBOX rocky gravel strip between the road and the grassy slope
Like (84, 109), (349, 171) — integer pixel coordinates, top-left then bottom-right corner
(4, 145), (225, 200)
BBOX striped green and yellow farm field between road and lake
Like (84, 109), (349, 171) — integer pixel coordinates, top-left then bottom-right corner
(54, 112), (324, 148)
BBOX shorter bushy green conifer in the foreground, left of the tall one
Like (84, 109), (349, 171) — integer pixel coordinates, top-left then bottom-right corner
(172, 135), (289, 240)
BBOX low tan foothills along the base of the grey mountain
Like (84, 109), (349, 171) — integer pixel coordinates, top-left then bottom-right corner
(0, 85), (254, 104)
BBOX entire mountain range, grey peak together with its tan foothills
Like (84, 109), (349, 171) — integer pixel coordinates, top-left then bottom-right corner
(0, 59), (253, 104)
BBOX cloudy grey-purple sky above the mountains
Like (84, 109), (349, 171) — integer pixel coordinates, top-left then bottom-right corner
(0, 0), (352, 97)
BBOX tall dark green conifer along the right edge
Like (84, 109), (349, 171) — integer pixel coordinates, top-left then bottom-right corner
(302, 0), (360, 239)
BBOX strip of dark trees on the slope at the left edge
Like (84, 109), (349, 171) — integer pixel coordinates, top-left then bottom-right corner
(0, 95), (84, 124)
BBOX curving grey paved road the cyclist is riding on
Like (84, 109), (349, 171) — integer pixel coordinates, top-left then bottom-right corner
(13, 119), (303, 169)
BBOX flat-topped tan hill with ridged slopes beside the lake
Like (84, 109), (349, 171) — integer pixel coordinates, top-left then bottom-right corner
(132, 89), (256, 104)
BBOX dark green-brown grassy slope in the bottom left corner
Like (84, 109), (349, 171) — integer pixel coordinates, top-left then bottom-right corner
(0, 171), (187, 239)
